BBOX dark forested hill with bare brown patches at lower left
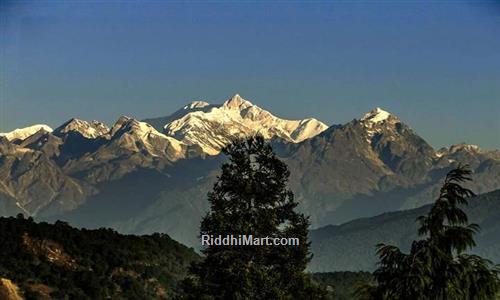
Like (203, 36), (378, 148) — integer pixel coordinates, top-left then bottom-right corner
(0, 217), (199, 299)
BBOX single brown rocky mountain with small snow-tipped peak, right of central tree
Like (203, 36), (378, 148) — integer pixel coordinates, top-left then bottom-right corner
(280, 108), (434, 221)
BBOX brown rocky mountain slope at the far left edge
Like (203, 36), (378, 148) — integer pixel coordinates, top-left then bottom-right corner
(0, 138), (94, 215)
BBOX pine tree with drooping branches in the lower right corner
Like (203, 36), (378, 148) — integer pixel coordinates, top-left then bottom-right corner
(358, 166), (500, 300)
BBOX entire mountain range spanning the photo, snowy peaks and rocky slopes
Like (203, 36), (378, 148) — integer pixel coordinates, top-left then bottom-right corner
(0, 95), (500, 247)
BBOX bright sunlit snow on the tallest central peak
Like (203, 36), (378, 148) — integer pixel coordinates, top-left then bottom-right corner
(164, 94), (328, 155)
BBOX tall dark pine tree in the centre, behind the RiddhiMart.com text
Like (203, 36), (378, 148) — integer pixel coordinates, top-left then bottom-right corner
(183, 136), (324, 299)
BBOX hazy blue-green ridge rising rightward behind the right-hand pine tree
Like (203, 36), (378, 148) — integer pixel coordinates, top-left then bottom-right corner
(309, 190), (500, 272)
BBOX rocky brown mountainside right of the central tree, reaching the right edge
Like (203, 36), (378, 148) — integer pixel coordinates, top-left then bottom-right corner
(285, 108), (500, 225)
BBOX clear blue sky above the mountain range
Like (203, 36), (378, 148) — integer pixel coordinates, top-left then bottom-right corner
(0, 0), (500, 149)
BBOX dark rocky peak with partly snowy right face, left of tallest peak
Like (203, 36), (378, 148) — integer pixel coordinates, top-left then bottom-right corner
(62, 116), (196, 183)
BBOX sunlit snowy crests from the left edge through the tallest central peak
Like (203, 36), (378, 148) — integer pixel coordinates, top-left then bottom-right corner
(4, 94), (328, 160)
